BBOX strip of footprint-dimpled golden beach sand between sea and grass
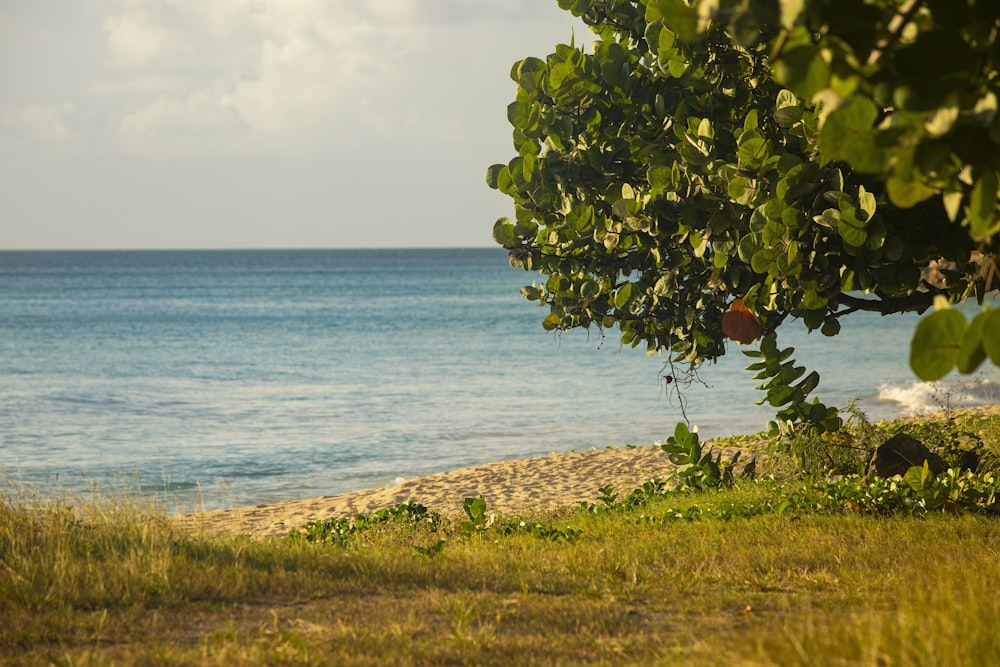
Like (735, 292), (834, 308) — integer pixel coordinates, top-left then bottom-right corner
(173, 445), (737, 538)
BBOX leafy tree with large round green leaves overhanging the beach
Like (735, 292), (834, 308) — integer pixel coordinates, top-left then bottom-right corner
(487, 0), (1000, 436)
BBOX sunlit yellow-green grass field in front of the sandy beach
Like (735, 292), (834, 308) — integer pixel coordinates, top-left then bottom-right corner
(0, 410), (1000, 665)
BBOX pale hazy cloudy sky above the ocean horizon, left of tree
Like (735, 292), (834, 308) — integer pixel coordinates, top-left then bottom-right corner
(0, 0), (590, 250)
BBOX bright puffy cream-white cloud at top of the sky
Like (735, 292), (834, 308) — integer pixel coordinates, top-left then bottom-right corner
(100, 0), (428, 151)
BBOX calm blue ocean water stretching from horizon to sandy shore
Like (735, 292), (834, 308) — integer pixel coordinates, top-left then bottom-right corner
(0, 248), (1000, 509)
